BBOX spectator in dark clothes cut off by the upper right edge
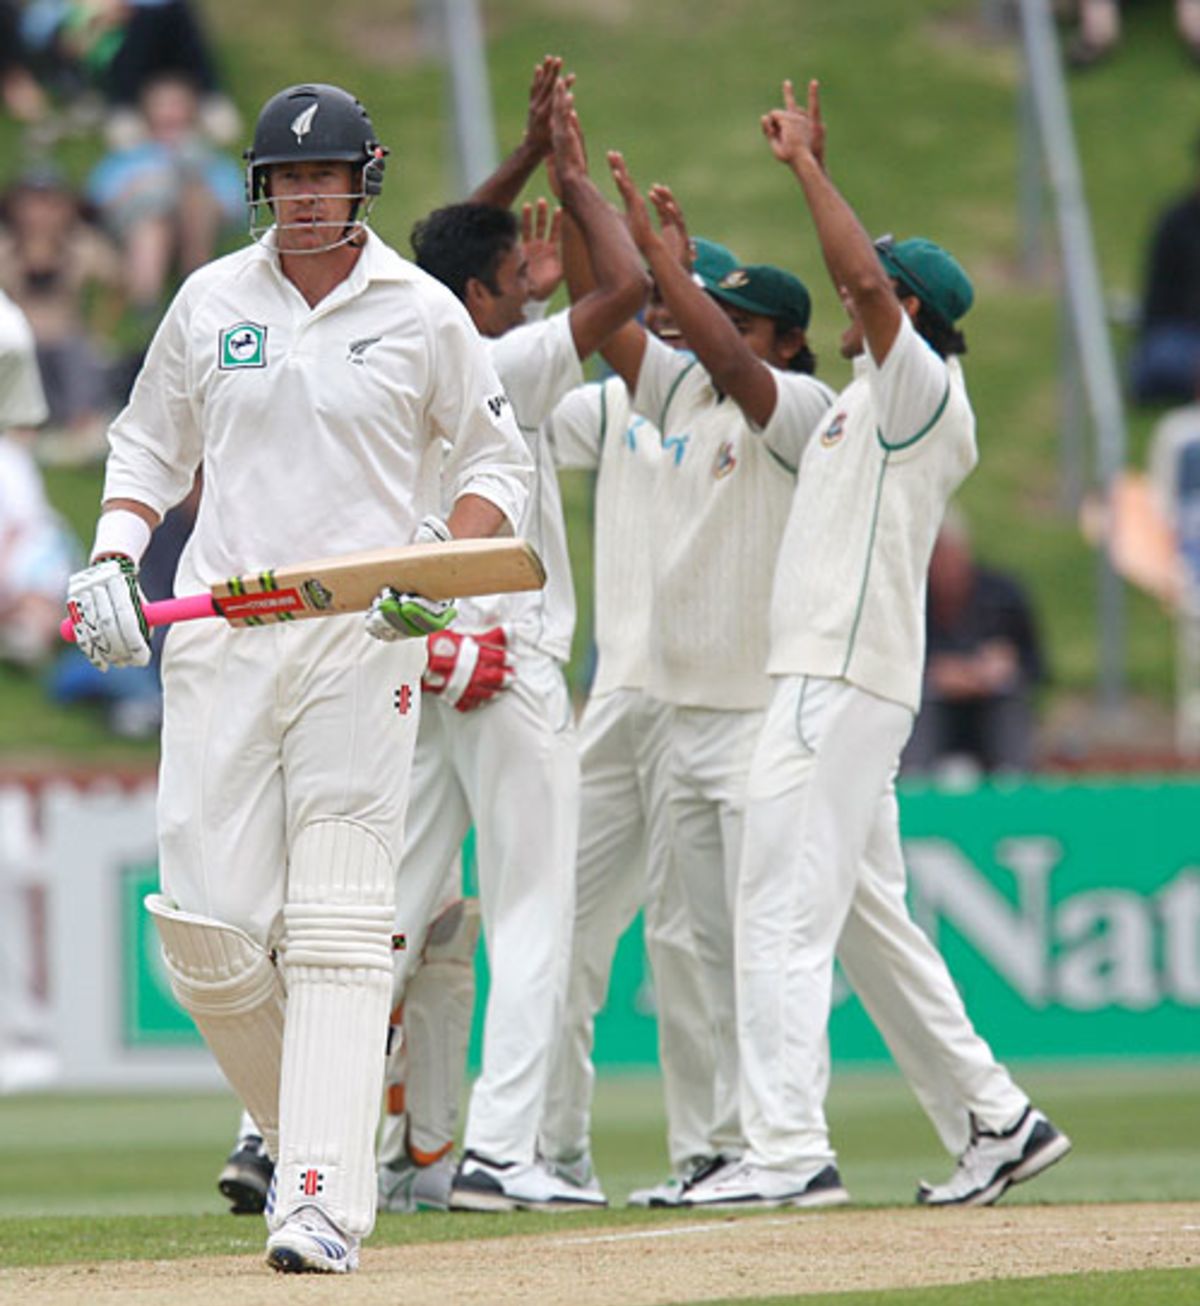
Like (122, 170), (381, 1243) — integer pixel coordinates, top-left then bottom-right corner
(1131, 131), (1200, 404)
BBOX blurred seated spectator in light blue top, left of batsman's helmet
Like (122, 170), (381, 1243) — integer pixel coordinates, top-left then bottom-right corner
(87, 73), (245, 319)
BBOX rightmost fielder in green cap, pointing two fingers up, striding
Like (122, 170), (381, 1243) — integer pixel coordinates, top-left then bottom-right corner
(686, 82), (1071, 1207)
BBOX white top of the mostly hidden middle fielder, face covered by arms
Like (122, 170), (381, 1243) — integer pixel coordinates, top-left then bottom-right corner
(546, 376), (662, 696)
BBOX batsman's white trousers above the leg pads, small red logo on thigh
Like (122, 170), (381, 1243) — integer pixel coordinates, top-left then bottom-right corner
(158, 615), (426, 945)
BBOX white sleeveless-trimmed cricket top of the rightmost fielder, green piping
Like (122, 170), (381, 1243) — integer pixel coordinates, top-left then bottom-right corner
(769, 316), (978, 712)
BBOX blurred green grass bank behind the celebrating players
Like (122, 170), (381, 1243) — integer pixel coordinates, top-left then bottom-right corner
(0, 0), (1200, 754)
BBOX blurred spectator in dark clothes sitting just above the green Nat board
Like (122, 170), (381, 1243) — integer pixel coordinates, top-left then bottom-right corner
(901, 509), (1045, 776)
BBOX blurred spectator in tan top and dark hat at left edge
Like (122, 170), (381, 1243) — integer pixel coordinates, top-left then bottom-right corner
(0, 168), (121, 461)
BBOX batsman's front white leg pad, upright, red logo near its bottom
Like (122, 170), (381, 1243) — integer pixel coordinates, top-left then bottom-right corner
(275, 819), (396, 1238)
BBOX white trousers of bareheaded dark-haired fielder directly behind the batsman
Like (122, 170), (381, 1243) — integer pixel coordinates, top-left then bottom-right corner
(397, 653), (578, 1162)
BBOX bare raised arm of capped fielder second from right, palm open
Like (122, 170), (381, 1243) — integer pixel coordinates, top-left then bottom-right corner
(608, 151), (778, 426)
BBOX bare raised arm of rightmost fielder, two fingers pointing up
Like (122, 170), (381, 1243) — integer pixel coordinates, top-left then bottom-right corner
(763, 81), (904, 363)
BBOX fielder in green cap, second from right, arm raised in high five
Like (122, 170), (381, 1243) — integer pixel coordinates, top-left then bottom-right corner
(605, 154), (833, 1179)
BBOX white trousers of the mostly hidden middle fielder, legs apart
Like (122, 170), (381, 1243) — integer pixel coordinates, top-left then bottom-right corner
(541, 690), (713, 1170)
